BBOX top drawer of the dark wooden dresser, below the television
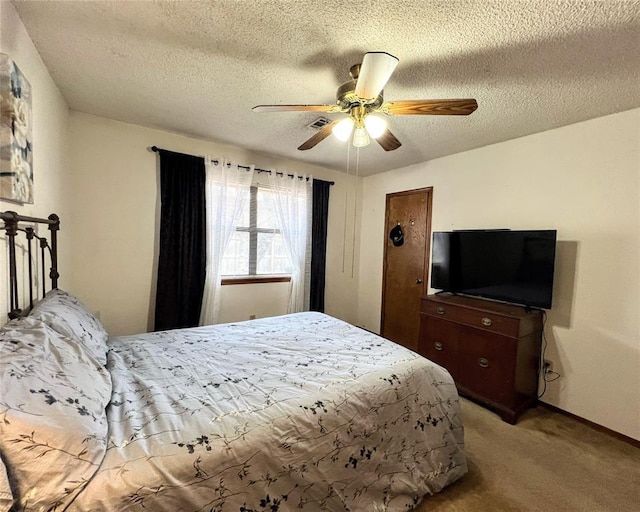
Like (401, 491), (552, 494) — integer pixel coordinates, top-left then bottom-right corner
(422, 300), (520, 338)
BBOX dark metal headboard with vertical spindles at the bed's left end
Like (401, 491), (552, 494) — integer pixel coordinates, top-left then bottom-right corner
(0, 211), (60, 318)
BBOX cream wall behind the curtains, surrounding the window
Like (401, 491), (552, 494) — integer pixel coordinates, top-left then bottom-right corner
(67, 112), (357, 334)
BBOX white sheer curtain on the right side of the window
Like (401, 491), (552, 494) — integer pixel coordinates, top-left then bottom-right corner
(269, 171), (313, 313)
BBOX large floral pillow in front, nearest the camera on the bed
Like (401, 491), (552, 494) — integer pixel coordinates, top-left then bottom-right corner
(0, 317), (111, 510)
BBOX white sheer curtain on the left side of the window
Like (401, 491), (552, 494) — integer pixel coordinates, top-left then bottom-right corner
(200, 158), (254, 325)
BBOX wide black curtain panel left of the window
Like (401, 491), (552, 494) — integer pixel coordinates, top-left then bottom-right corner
(155, 150), (206, 331)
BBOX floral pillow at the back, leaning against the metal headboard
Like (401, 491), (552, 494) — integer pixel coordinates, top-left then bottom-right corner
(29, 289), (109, 366)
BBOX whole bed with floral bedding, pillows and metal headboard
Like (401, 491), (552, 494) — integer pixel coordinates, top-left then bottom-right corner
(0, 210), (467, 512)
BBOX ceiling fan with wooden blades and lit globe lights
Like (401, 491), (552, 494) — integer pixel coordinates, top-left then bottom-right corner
(253, 52), (478, 151)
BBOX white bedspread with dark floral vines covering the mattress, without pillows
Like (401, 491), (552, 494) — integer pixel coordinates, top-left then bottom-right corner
(69, 313), (467, 512)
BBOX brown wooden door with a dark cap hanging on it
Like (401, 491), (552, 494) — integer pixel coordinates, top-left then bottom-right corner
(380, 187), (432, 351)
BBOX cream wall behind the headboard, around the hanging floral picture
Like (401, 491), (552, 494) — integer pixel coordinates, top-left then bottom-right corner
(0, 1), (71, 324)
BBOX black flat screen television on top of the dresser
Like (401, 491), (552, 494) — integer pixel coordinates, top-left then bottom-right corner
(431, 229), (556, 309)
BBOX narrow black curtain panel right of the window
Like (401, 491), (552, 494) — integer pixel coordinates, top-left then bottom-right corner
(309, 179), (331, 313)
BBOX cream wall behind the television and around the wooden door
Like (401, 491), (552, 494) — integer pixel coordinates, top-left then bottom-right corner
(358, 109), (640, 439)
